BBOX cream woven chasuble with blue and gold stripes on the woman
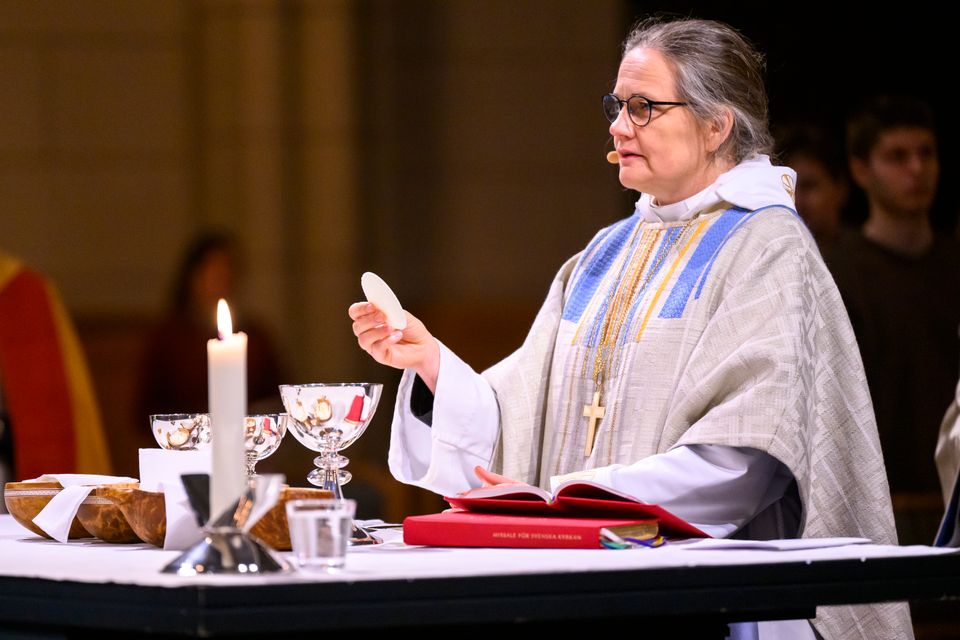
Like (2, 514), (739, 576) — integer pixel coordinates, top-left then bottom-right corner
(484, 207), (912, 638)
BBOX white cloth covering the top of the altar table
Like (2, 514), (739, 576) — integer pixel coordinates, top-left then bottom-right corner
(0, 515), (956, 588)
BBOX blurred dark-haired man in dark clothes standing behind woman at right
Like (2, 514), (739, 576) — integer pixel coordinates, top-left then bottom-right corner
(823, 96), (960, 544)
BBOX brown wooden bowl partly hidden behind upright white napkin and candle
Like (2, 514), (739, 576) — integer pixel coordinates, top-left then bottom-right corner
(100, 485), (333, 551)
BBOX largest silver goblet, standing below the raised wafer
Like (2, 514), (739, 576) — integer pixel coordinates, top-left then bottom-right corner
(280, 382), (383, 545)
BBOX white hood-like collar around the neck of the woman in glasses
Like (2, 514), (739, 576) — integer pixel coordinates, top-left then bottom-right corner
(636, 155), (797, 222)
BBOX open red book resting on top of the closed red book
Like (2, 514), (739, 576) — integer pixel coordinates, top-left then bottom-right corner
(444, 480), (710, 538)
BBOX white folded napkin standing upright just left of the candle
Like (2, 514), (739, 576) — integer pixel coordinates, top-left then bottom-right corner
(140, 449), (213, 550)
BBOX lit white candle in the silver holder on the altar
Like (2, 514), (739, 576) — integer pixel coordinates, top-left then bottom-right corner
(207, 299), (247, 520)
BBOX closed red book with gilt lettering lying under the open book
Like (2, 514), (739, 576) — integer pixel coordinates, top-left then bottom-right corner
(403, 509), (657, 549)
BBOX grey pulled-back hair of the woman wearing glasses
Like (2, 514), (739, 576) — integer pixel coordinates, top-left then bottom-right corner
(623, 18), (773, 163)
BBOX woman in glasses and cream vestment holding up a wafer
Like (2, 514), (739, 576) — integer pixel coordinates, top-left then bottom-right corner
(349, 15), (912, 639)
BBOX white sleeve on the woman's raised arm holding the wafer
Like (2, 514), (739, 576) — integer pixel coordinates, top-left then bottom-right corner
(388, 343), (500, 496)
